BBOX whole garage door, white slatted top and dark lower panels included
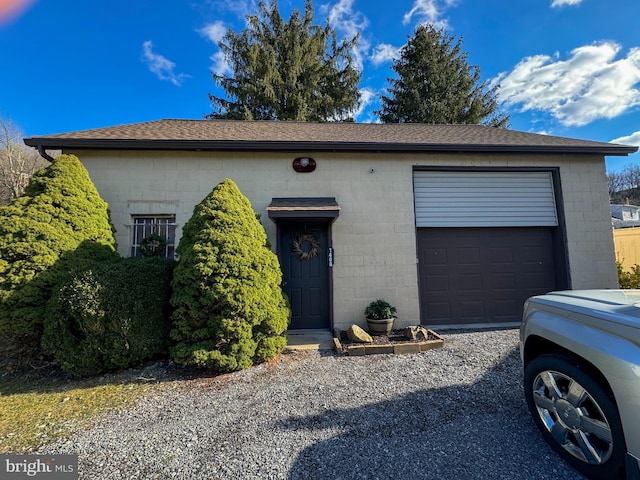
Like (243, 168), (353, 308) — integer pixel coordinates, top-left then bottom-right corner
(414, 170), (567, 326)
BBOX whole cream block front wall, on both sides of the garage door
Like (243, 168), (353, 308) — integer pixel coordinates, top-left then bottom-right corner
(67, 151), (617, 328)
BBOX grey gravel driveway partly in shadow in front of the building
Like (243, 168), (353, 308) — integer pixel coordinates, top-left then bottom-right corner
(38, 329), (582, 480)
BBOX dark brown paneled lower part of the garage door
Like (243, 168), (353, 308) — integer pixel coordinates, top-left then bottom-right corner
(418, 227), (556, 325)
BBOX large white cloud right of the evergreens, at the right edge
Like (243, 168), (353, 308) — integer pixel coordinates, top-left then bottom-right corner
(491, 42), (640, 126)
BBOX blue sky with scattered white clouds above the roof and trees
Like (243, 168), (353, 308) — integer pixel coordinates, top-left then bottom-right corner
(0, 0), (640, 171)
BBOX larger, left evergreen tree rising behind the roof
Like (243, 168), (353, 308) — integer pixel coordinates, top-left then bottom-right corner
(208, 0), (360, 121)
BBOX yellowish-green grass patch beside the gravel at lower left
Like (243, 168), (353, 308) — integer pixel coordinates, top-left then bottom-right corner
(0, 366), (171, 454)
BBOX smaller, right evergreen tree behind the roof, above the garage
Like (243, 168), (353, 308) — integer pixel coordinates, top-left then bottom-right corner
(376, 25), (509, 127)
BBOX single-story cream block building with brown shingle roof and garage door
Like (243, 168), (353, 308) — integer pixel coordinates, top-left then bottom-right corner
(25, 120), (637, 329)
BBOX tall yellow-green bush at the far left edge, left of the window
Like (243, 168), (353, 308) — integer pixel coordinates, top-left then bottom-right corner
(0, 155), (116, 344)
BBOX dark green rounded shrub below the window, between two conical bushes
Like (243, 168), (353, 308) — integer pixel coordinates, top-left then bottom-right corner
(42, 258), (175, 376)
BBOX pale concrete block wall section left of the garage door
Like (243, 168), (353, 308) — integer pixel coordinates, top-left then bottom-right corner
(75, 151), (420, 328)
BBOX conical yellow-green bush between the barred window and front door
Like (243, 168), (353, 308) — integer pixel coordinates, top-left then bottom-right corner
(171, 179), (289, 371)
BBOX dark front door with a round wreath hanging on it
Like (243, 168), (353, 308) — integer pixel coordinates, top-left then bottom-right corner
(278, 221), (331, 330)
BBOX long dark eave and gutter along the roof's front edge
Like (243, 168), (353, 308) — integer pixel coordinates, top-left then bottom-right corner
(24, 137), (638, 156)
